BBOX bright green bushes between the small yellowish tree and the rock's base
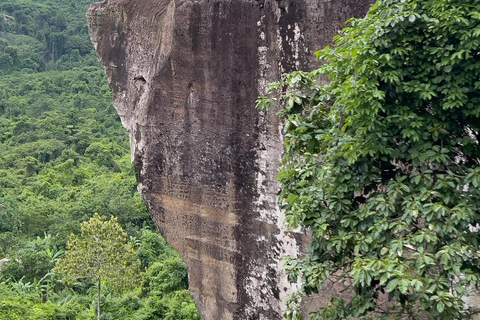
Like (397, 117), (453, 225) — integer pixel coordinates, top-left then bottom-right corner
(89, 229), (200, 320)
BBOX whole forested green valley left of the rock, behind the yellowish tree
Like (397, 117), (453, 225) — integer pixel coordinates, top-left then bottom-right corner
(0, 0), (200, 320)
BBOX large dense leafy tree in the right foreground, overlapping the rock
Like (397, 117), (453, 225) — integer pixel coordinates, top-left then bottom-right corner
(259, 0), (480, 320)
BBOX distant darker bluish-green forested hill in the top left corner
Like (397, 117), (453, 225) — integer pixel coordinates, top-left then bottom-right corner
(0, 0), (95, 74)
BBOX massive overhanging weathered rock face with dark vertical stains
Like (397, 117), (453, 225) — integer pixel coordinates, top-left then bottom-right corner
(88, 0), (370, 320)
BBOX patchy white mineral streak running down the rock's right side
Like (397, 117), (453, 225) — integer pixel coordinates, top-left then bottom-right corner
(249, 11), (300, 319)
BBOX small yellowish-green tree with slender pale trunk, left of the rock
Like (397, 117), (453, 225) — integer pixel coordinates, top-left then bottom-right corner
(54, 213), (140, 320)
